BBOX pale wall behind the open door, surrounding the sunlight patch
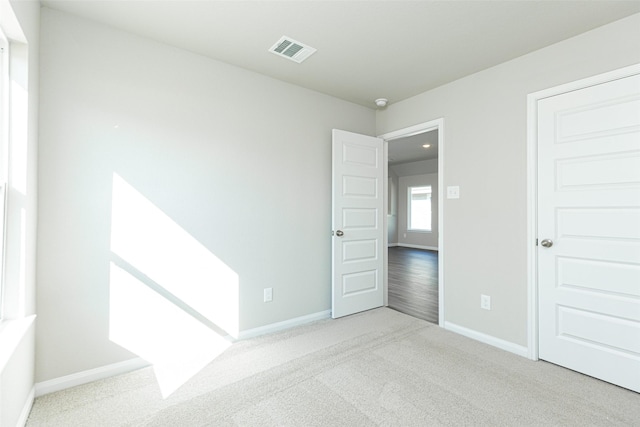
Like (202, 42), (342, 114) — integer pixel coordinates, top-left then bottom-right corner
(37, 8), (375, 382)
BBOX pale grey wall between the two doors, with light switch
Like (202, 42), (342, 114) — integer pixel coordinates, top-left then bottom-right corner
(376, 15), (640, 346)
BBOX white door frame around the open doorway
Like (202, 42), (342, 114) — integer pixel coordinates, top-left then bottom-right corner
(378, 118), (445, 327)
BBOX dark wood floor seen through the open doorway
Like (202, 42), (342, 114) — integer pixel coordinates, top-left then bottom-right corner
(389, 247), (438, 323)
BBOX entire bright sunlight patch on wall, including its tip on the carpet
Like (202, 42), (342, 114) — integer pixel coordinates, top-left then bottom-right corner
(109, 174), (239, 397)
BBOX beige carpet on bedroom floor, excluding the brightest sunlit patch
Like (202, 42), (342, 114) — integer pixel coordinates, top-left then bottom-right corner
(27, 308), (640, 426)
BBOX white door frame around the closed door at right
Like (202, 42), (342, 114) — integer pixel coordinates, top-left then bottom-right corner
(527, 64), (640, 360)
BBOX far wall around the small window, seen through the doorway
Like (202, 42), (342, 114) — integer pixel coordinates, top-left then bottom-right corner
(398, 173), (438, 250)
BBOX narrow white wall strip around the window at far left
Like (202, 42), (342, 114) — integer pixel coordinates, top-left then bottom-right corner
(0, 0), (40, 426)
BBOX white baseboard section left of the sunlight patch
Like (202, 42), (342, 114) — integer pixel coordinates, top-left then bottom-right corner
(35, 357), (149, 397)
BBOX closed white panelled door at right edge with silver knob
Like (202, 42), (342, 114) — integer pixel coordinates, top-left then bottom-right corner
(537, 75), (640, 392)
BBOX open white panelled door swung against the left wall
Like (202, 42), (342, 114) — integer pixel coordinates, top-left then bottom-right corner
(332, 129), (385, 318)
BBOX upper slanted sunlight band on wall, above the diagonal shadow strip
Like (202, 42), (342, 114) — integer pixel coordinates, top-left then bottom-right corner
(111, 174), (239, 338)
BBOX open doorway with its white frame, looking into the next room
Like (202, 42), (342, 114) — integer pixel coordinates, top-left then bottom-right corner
(380, 119), (445, 326)
